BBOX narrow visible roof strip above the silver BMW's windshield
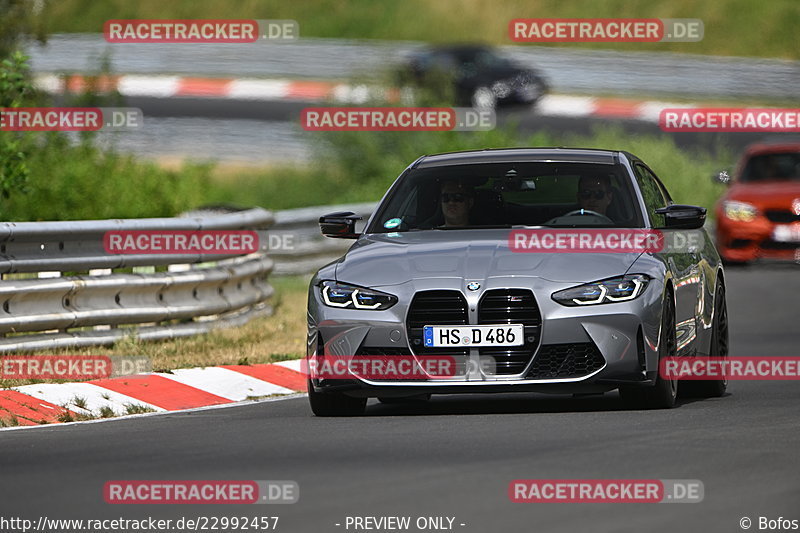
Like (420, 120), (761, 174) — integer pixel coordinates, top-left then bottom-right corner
(412, 148), (624, 168)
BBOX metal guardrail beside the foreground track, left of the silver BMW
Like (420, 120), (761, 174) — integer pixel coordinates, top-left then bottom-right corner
(0, 209), (274, 353)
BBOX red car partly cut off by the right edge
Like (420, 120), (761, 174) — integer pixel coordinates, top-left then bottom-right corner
(716, 141), (800, 263)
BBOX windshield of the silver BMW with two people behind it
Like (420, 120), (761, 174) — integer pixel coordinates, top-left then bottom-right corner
(368, 163), (643, 233)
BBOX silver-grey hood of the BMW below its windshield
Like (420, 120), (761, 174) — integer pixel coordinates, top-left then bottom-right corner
(336, 230), (641, 287)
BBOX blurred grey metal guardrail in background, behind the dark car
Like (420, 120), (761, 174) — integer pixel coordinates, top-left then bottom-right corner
(26, 34), (800, 101)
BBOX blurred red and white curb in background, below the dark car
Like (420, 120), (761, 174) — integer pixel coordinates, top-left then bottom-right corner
(35, 74), (696, 123)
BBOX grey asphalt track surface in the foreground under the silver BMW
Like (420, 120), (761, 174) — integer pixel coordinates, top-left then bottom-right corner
(0, 265), (800, 533)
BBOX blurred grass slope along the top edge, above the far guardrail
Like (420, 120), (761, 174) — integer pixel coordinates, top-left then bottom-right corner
(46, 0), (800, 59)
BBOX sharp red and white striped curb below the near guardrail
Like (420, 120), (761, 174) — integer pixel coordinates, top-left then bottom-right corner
(0, 359), (306, 426)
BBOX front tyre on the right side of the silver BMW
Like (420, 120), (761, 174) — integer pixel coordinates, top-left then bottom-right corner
(619, 294), (678, 409)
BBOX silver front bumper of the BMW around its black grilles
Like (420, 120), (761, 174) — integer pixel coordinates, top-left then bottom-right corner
(308, 276), (662, 396)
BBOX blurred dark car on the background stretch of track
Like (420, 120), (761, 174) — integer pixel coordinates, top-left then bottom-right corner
(400, 45), (547, 109)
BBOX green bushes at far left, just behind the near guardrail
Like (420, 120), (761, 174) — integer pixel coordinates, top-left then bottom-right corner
(0, 52), (216, 221)
